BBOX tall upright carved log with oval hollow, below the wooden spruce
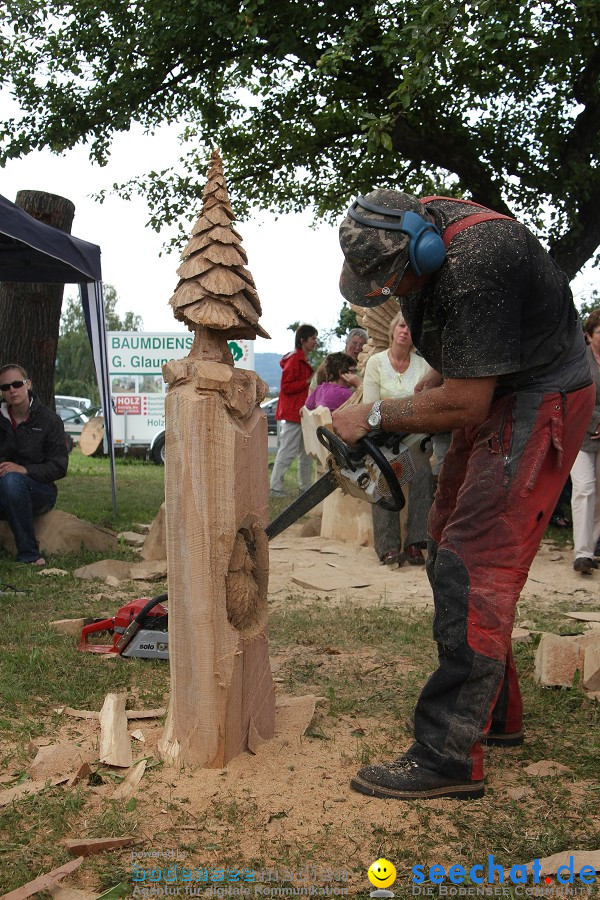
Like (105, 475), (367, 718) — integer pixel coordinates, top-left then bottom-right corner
(159, 345), (275, 768)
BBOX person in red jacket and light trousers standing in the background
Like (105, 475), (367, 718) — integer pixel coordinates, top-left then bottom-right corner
(271, 325), (318, 497)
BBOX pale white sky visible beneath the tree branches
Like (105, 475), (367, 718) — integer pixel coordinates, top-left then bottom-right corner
(0, 110), (350, 354)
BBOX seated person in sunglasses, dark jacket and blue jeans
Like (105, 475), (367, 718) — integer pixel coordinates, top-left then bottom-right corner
(0, 363), (69, 566)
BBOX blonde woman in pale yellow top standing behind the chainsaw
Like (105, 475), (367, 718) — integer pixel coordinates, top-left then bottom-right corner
(363, 312), (433, 565)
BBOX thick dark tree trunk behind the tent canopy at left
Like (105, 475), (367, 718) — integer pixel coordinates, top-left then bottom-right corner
(0, 191), (75, 409)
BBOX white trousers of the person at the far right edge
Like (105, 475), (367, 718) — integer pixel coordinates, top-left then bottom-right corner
(571, 447), (600, 559)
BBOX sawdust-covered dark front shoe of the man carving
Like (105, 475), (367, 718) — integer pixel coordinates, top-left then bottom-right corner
(350, 756), (483, 800)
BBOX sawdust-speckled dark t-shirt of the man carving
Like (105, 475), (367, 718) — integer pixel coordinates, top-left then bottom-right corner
(401, 200), (591, 394)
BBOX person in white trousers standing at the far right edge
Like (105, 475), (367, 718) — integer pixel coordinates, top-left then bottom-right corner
(571, 309), (600, 575)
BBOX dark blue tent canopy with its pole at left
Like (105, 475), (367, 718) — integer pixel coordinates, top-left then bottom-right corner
(0, 190), (116, 513)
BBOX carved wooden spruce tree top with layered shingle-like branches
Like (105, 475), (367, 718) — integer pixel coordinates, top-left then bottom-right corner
(169, 150), (269, 340)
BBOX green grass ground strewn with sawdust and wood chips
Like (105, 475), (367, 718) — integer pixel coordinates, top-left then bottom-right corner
(0, 451), (600, 898)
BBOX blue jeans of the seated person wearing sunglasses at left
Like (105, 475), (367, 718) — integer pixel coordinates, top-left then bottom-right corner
(0, 472), (58, 562)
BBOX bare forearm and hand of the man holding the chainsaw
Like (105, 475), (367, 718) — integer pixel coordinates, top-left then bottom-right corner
(332, 375), (496, 444)
